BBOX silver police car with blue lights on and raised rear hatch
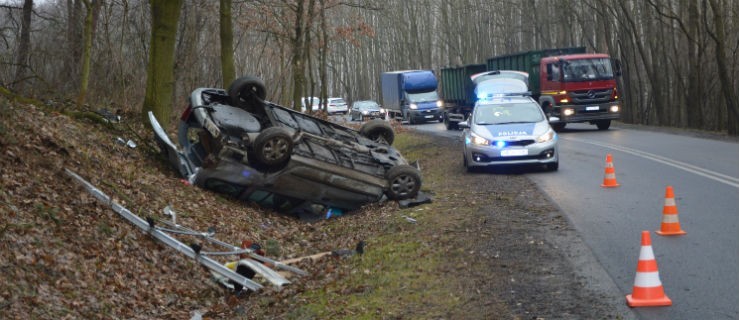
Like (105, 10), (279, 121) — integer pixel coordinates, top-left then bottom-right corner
(459, 93), (559, 172)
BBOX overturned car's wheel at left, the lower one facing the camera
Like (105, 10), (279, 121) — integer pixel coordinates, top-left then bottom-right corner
(253, 127), (293, 171)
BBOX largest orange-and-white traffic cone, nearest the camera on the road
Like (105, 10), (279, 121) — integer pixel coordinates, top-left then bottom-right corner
(626, 231), (672, 307)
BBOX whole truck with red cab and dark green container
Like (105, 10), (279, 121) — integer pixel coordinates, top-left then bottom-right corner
(486, 47), (621, 130)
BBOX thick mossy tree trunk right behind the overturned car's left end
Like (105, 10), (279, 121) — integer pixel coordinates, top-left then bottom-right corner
(142, 0), (182, 128)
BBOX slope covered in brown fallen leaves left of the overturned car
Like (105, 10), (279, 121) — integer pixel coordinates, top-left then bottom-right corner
(0, 101), (382, 318)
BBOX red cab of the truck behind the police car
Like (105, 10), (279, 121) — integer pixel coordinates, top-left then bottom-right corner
(539, 53), (621, 130)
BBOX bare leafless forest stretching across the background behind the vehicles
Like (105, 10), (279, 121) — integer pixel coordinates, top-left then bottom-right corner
(0, 0), (739, 135)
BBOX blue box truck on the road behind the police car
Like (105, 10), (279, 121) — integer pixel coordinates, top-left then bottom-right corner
(380, 70), (442, 124)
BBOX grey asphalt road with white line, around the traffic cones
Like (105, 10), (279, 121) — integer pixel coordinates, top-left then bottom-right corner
(404, 119), (739, 319)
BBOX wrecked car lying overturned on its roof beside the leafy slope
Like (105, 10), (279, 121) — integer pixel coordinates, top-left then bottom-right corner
(149, 77), (421, 214)
